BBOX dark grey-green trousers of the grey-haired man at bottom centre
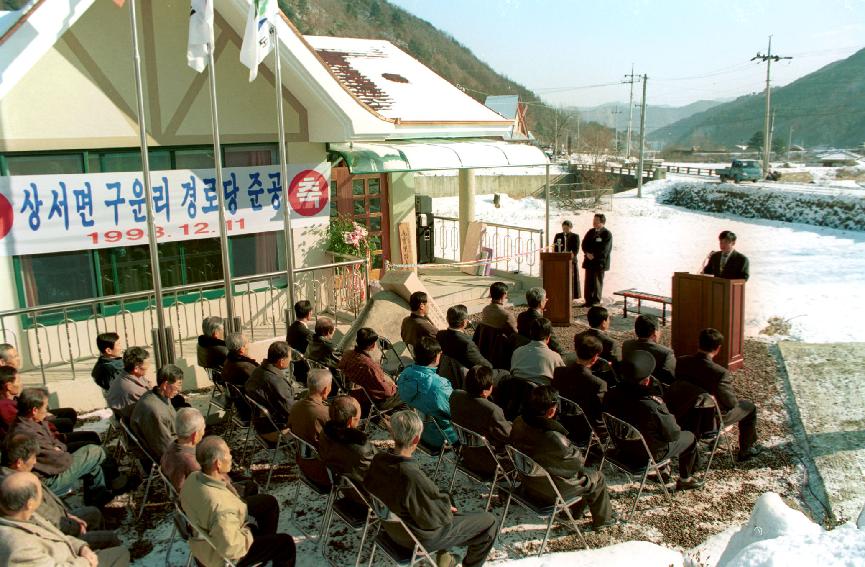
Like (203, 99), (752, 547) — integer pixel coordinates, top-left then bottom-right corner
(394, 512), (498, 567)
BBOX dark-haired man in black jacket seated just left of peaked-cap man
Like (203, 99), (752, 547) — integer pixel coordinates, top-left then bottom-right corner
(553, 335), (607, 433)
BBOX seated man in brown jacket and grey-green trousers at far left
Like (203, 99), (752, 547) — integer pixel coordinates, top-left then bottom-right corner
(9, 388), (111, 505)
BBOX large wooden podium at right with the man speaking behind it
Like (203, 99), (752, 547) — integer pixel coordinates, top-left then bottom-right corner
(672, 272), (745, 371)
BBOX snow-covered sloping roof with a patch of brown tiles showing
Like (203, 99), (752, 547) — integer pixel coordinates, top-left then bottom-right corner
(304, 36), (509, 124)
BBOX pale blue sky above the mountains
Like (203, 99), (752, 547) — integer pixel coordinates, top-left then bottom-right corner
(389, 0), (865, 107)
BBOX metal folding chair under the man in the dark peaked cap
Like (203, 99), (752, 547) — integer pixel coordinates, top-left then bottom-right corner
(598, 412), (673, 521)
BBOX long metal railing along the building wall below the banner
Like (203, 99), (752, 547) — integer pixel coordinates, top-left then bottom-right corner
(0, 259), (369, 384)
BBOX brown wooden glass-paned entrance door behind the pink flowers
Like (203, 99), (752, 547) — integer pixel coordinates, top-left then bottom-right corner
(333, 167), (390, 279)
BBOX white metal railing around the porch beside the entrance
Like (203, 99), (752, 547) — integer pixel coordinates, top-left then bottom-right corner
(433, 215), (544, 276)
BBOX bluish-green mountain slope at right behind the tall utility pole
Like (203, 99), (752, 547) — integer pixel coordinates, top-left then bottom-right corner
(647, 49), (865, 148)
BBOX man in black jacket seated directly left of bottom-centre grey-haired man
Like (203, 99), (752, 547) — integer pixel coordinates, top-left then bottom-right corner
(318, 396), (375, 486)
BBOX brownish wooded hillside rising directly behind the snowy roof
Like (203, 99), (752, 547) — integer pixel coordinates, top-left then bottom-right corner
(279, 0), (612, 144)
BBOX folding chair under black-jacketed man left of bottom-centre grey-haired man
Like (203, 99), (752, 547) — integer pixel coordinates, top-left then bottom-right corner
(319, 467), (375, 567)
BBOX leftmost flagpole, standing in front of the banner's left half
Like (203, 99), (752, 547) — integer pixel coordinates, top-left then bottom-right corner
(129, 0), (174, 366)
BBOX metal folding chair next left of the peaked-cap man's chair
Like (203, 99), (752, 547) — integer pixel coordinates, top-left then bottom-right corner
(499, 445), (589, 557)
